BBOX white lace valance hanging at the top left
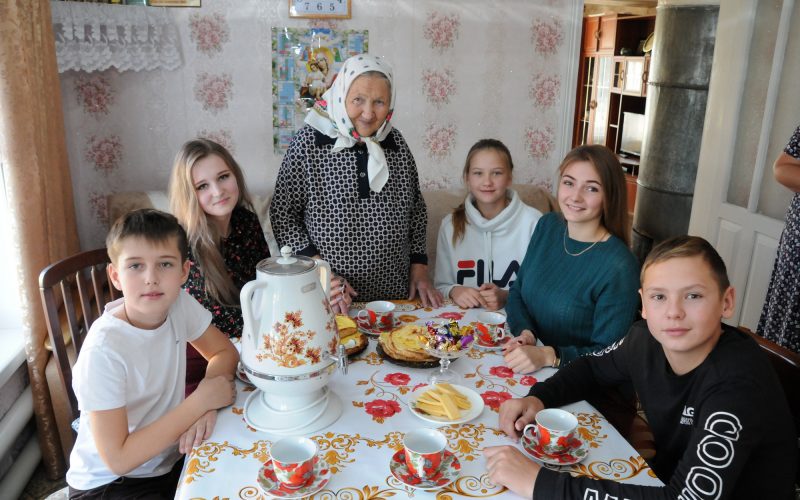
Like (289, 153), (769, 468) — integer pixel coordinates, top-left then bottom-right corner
(50, 1), (182, 73)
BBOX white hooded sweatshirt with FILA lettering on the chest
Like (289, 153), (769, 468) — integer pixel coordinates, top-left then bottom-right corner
(434, 189), (542, 297)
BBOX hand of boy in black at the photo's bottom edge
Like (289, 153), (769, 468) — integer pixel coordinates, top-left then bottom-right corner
(483, 445), (541, 498)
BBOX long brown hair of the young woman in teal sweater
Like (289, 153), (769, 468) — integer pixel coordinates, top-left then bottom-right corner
(558, 144), (631, 246)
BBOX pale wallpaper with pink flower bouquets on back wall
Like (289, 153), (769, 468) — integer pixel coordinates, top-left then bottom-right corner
(61, 0), (582, 248)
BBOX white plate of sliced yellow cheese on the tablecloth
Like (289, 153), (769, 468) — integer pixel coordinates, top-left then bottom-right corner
(409, 383), (484, 424)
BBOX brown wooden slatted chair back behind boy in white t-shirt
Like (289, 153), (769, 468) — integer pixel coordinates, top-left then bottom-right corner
(39, 248), (121, 420)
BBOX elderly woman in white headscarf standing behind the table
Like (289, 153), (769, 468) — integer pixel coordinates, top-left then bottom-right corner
(270, 54), (442, 313)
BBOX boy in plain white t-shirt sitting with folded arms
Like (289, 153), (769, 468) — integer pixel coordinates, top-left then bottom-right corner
(67, 209), (239, 499)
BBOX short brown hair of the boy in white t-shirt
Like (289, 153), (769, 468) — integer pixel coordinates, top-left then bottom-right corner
(106, 208), (189, 263)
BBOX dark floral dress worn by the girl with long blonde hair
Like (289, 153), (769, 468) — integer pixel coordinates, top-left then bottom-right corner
(183, 207), (269, 396)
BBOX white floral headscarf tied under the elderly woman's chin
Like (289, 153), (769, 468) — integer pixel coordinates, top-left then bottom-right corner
(305, 54), (396, 193)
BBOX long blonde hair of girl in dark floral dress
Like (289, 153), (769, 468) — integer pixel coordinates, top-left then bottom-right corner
(169, 139), (253, 305)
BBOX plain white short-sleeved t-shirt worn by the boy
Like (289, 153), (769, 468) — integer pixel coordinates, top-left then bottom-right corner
(67, 290), (211, 490)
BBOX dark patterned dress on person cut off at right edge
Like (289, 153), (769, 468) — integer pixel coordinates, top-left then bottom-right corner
(757, 127), (800, 352)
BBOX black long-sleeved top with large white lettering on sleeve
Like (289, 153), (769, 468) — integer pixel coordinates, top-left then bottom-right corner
(530, 321), (797, 500)
